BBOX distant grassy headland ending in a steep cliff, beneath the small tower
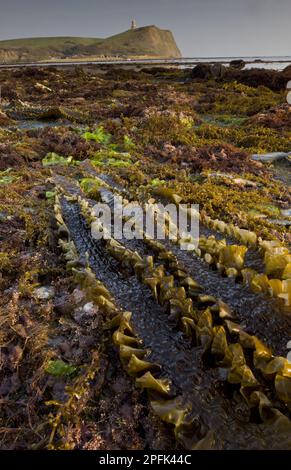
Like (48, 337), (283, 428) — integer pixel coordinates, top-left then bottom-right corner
(0, 26), (181, 63)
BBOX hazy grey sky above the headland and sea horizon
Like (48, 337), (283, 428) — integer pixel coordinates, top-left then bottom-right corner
(0, 0), (291, 57)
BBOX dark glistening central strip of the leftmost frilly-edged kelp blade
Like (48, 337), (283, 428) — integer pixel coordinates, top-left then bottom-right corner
(62, 198), (289, 449)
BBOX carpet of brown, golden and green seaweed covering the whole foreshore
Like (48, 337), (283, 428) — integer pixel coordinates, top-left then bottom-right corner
(0, 62), (291, 450)
